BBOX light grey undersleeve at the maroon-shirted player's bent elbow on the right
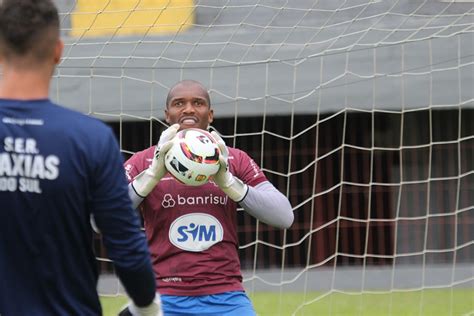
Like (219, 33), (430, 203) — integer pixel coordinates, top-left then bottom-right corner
(239, 182), (294, 228)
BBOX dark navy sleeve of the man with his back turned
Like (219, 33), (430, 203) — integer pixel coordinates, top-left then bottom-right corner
(91, 129), (156, 306)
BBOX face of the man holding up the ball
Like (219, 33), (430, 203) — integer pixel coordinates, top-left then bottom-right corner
(165, 84), (214, 130)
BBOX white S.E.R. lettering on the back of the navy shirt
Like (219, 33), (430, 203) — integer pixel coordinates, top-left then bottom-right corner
(0, 137), (60, 194)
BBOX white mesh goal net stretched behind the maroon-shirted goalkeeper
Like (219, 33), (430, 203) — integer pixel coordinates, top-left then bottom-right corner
(52, 0), (474, 315)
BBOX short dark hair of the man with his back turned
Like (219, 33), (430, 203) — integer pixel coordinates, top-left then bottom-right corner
(0, 0), (59, 60)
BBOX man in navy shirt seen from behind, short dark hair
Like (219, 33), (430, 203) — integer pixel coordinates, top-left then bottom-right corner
(0, 0), (161, 316)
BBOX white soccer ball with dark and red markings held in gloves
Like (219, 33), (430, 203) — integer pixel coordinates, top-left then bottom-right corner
(165, 128), (220, 186)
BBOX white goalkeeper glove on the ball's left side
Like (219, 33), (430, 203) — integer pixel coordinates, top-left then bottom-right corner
(132, 124), (179, 198)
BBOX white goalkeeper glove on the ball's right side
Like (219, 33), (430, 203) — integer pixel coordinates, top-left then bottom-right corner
(211, 131), (249, 202)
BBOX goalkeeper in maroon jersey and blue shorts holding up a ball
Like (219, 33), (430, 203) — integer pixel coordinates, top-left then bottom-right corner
(125, 80), (293, 316)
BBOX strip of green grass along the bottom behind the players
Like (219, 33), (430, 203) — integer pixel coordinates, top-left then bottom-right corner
(101, 289), (474, 316)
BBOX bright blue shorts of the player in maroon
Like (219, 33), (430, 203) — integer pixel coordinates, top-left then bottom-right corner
(161, 292), (256, 316)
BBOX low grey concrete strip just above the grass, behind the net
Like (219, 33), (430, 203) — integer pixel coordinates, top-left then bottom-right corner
(98, 265), (474, 294)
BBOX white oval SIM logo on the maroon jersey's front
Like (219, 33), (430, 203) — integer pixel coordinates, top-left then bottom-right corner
(169, 213), (224, 252)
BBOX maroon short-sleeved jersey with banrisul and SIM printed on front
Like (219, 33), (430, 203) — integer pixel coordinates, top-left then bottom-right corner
(125, 147), (267, 296)
